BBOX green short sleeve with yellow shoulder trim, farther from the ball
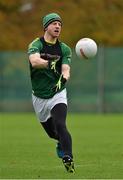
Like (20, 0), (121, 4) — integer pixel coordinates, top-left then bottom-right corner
(28, 38), (42, 55)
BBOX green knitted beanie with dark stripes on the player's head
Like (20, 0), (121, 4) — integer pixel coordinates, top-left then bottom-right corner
(43, 13), (62, 29)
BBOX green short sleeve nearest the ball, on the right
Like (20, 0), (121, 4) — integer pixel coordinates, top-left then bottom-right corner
(61, 43), (72, 65)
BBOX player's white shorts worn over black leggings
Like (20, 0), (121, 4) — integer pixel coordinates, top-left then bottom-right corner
(32, 89), (67, 122)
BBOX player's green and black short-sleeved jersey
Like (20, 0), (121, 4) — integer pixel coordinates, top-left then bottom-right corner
(28, 37), (72, 99)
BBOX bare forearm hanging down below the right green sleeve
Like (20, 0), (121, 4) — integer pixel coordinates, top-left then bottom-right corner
(62, 64), (70, 80)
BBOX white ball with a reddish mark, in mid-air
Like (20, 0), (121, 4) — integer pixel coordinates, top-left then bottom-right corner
(75, 38), (97, 59)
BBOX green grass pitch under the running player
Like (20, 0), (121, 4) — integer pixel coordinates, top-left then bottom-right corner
(0, 113), (123, 179)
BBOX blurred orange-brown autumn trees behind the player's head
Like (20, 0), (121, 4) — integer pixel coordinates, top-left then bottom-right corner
(0, 0), (123, 51)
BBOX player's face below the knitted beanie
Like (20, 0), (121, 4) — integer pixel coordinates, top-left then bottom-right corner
(47, 21), (61, 38)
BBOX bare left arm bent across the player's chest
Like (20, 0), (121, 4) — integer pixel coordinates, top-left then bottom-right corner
(29, 53), (48, 69)
